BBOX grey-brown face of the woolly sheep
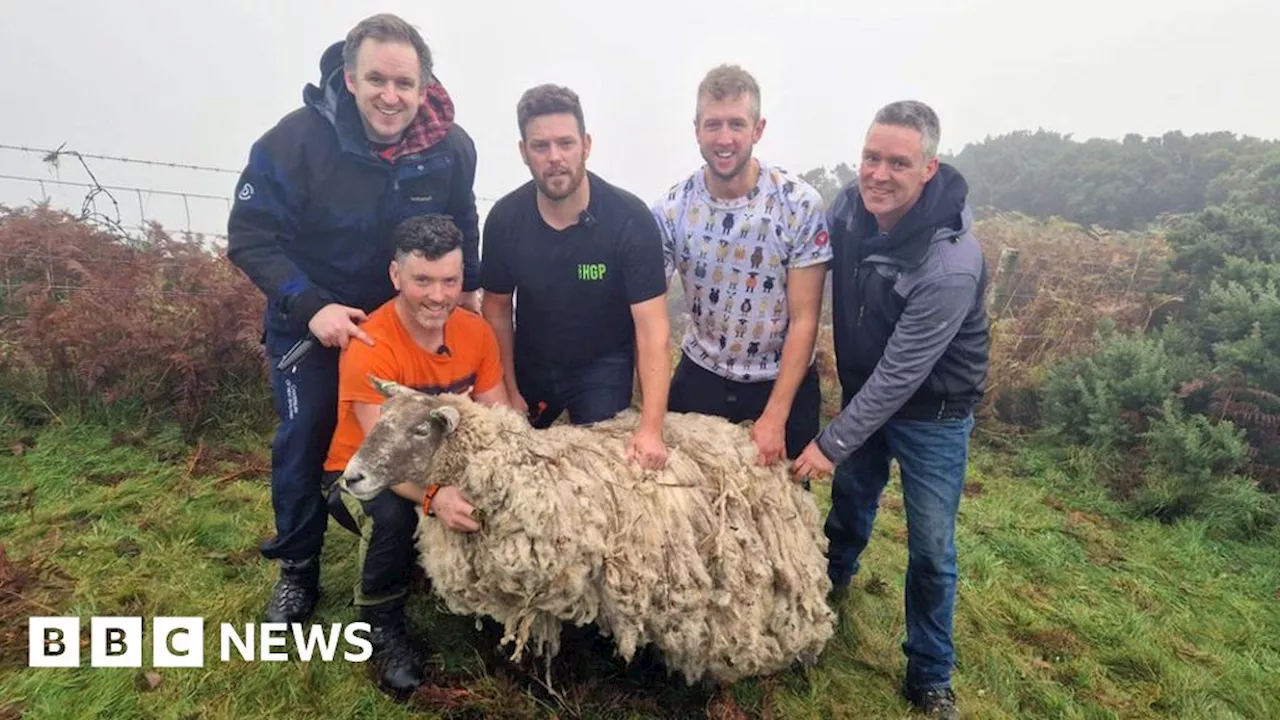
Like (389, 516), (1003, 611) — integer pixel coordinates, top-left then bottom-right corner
(342, 377), (460, 500)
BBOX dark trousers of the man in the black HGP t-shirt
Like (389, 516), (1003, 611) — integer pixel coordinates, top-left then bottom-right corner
(516, 347), (635, 429)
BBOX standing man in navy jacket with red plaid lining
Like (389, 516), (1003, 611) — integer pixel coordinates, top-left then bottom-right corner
(227, 15), (479, 632)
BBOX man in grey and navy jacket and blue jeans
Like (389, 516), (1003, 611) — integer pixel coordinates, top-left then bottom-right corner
(792, 101), (991, 717)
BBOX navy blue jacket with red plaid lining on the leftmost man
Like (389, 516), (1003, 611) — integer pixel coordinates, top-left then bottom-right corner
(227, 42), (480, 338)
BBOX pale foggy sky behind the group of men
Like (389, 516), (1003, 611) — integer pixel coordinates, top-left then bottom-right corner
(0, 0), (1280, 232)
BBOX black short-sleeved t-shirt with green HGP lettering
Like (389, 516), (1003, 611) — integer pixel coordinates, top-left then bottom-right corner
(480, 173), (667, 366)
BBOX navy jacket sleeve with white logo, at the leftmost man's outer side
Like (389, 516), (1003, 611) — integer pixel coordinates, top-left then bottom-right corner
(227, 138), (332, 329)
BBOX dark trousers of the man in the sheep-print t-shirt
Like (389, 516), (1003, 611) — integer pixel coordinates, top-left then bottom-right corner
(667, 355), (822, 460)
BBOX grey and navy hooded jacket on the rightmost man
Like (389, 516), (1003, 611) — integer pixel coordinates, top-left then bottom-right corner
(818, 164), (991, 462)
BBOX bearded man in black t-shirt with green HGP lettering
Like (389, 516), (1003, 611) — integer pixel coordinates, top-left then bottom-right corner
(480, 85), (671, 469)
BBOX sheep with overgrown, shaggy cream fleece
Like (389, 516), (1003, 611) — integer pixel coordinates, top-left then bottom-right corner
(340, 378), (836, 684)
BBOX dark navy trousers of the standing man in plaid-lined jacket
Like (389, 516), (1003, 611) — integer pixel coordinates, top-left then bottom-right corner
(261, 332), (338, 560)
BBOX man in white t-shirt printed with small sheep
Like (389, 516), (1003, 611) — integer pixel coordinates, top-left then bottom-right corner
(653, 65), (831, 464)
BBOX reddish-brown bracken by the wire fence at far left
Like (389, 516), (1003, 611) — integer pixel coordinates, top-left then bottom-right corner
(0, 206), (266, 437)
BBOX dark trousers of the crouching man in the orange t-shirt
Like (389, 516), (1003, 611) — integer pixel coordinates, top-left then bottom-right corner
(324, 473), (419, 607)
